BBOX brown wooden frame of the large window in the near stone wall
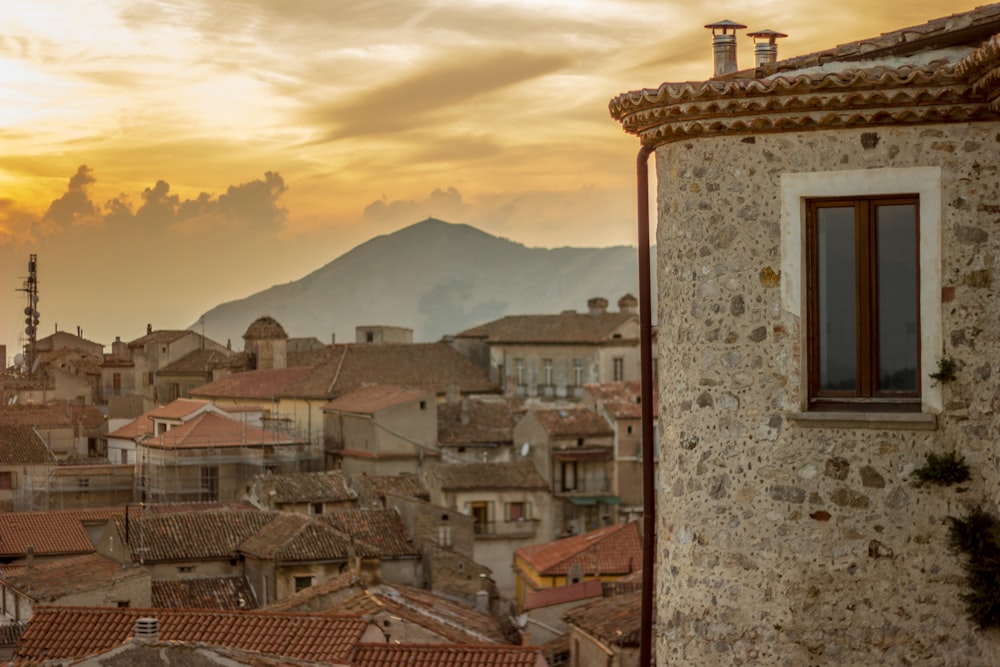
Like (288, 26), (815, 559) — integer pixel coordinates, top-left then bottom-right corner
(805, 194), (922, 412)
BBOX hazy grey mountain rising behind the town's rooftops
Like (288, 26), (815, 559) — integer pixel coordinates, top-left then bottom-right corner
(190, 218), (655, 350)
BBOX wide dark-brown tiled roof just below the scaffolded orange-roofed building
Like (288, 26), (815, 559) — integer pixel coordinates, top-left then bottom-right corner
(114, 509), (277, 563)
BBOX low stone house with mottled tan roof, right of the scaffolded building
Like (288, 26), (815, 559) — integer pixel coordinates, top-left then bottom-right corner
(246, 470), (358, 516)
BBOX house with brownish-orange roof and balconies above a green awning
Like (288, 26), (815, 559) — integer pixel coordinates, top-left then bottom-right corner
(514, 407), (621, 538)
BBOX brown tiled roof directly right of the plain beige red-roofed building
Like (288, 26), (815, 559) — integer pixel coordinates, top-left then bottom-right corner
(438, 398), (524, 445)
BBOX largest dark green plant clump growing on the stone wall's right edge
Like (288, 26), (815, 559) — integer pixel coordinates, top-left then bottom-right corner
(948, 508), (1000, 628)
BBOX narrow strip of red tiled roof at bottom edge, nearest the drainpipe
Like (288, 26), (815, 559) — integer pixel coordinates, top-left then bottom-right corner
(351, 644), (541, 667)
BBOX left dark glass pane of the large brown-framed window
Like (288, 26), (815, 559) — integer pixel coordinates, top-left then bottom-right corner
(816, 207), (858, 391)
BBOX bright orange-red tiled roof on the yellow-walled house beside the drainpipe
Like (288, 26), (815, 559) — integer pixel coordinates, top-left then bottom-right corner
(514, 521), (642, 576)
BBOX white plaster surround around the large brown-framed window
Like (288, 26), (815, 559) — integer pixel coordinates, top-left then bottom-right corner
(781, 167), (944, 428)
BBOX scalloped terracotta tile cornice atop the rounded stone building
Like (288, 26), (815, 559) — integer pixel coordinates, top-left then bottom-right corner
(609, 36), (1000, 147)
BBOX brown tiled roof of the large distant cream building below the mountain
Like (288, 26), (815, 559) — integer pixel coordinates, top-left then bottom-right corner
(456, 312), (639, 344)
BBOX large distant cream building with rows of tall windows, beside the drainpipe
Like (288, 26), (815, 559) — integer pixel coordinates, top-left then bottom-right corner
(451, 294), (639, 400)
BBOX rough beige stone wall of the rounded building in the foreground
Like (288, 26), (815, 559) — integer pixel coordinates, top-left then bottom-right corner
(656, 122), (1000, 665)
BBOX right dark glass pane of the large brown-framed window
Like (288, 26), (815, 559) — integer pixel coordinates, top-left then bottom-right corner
(875, 204), (919, 392)
